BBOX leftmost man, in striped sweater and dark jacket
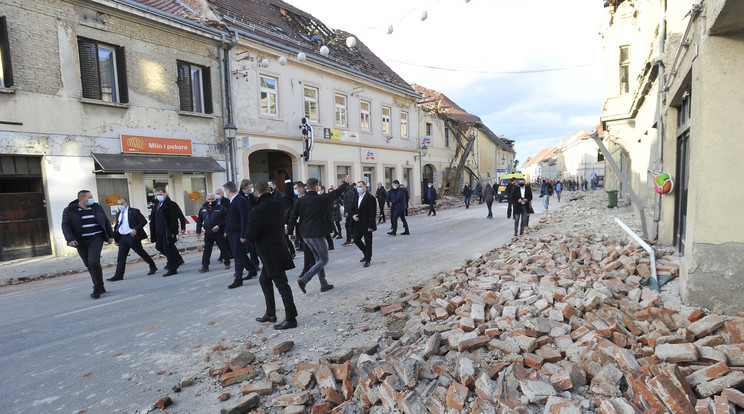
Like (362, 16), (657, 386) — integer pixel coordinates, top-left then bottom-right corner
(62, 190), (114, 299)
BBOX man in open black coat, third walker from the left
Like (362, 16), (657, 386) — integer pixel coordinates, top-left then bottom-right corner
(150, 188), (186, 277)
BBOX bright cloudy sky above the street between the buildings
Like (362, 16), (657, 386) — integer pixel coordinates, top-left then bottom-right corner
(285, 0), (604, 165)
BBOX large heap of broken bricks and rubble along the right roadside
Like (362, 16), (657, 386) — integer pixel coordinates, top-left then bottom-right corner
(205, 192), (744, 414)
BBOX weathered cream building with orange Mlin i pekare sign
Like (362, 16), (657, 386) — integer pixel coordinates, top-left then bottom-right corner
(0, 0), (224, 260)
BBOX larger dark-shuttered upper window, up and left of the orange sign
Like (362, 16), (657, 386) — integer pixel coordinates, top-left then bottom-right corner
(78, 37), (129, 103)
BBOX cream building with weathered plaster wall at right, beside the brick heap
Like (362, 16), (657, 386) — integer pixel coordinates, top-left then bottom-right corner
(602, 0), (744, 313)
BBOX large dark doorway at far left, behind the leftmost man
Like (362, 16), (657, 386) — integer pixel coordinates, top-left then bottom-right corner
(0, 155), (51, 261)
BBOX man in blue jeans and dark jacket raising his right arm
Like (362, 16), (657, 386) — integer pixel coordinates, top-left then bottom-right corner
(287, 176), (348, 293)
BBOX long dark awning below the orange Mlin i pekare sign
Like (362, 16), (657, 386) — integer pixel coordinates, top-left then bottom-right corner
(91, 154), (225, 172)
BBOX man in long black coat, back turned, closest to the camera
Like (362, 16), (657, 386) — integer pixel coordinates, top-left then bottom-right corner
(244, 181), (297, 329)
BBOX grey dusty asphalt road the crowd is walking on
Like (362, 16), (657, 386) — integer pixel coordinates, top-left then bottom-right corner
(0, 204), (540, 413)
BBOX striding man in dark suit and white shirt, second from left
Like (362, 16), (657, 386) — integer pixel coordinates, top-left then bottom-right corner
(106, 197), (158, 282)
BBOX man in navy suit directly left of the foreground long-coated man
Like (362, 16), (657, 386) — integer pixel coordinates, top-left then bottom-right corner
(223, 181), (258, 289)
